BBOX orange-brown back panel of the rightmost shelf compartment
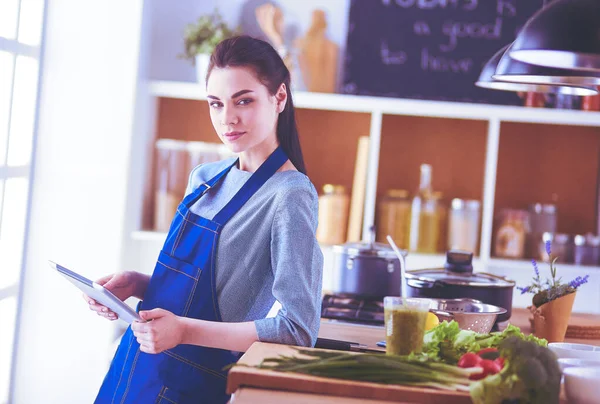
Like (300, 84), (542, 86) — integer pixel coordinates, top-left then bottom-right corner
(494, 123), (600, 234)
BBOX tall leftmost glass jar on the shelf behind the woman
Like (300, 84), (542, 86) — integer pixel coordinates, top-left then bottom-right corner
(154, 139), (189, 232)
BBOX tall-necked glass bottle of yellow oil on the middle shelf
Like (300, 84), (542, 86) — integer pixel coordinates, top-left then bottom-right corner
(408, 164), (439, 253)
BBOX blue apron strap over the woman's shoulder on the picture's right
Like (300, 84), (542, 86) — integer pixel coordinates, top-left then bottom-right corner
(213, 146), (288, 226)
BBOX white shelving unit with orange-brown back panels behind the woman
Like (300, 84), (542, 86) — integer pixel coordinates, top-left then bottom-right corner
(125, 81), (600, 312)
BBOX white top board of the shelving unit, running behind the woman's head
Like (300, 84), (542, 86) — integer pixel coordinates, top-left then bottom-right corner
(149, 81), (600, 126)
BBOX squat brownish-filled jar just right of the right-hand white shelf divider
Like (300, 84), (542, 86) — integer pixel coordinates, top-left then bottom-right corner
(494, 209), (529, 258)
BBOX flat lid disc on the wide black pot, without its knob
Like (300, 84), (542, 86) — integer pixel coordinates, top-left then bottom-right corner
(405, 268), (515, 288)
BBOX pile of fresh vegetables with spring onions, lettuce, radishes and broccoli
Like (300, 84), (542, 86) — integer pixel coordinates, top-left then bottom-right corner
(234, 321), (561, 404)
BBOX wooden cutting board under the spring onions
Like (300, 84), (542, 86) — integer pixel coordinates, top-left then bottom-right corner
(227, 342), (472, 404)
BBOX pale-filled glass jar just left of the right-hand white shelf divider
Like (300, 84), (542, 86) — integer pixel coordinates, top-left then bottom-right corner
(447, 198), (481, 254)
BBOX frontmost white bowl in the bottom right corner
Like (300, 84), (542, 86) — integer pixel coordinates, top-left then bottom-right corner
(564, 367), (600, 404)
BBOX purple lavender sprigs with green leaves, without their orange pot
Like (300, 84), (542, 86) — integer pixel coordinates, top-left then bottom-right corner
(517, 241), (590, 307)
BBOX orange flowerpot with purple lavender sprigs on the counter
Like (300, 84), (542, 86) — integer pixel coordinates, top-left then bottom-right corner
(517, 241), (589, 342)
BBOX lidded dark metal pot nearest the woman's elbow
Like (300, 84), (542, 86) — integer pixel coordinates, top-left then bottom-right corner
(333, 232), (405, 300)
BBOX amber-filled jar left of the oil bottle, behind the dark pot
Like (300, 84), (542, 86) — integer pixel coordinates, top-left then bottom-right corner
(377, 189), (411, 250)
